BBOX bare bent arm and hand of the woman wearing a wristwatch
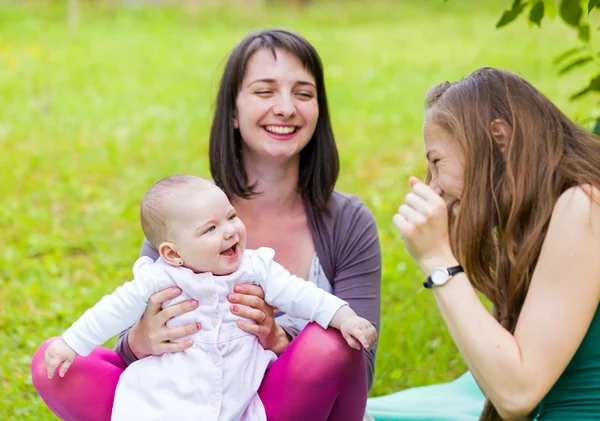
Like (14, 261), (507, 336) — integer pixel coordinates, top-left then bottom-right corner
(395, 184), (600, 420)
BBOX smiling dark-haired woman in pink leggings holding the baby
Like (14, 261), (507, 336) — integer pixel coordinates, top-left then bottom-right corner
(32, 30), (381, 421)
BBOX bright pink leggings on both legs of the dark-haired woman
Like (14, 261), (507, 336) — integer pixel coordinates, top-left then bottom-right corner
(31, 323), (367, 421)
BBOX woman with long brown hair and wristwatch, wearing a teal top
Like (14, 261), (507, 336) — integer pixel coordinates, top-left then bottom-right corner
(394, 68), (600, 421)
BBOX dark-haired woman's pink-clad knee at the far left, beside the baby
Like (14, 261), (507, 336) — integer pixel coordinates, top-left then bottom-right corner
(31, 337), (125, 421)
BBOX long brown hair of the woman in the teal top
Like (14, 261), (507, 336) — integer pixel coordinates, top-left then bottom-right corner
(425, 68), (600, 421)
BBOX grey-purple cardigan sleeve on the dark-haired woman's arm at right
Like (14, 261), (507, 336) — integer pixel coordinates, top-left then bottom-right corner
(332, 199), (381, 390)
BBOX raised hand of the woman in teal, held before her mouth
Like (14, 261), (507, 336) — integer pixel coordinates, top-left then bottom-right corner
(394, 177), (452, 268)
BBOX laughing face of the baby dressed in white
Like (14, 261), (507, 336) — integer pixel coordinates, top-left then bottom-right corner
(169, 186), (246, 275)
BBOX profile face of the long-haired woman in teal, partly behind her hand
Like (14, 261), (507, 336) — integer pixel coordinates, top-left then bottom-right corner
(423, 116), (465, 212)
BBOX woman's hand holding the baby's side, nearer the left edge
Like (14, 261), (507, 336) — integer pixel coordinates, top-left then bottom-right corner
(128, 287), (201, 359)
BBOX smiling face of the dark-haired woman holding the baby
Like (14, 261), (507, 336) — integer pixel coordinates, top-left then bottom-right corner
(234, 49), (319, 166)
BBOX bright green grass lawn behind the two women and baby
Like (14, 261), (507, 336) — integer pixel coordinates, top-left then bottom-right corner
(0, 0), (592, 420)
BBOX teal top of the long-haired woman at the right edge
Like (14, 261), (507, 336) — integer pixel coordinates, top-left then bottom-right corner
(537, 307), (600, 421)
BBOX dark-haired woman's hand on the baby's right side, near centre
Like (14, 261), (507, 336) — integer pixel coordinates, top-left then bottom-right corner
(227, 284), (290, 355)
